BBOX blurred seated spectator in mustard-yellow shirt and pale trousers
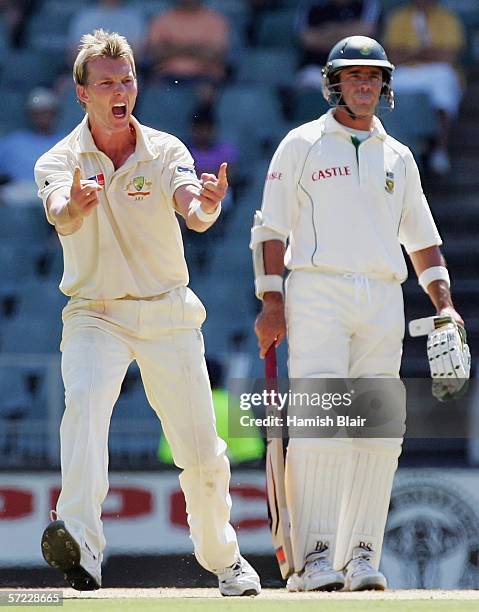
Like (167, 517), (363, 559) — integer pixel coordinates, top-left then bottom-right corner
(384, 0), (466, 174)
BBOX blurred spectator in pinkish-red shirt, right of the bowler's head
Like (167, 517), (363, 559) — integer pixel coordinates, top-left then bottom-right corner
(147, 0), (230, 84)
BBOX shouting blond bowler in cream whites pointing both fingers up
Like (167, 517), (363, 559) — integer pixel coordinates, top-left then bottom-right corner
(35, 30), (260, 596)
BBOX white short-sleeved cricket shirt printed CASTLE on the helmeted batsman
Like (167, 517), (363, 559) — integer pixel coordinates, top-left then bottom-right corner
(262, 109), (442, 282)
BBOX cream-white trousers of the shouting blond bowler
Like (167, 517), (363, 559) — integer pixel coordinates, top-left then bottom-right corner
(57, 287), (239, 571)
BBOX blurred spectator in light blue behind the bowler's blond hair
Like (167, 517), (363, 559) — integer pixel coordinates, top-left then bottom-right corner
(68, 0), (147, 63)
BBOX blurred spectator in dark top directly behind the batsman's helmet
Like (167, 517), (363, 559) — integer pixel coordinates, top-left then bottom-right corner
(297, 0), (381, 89)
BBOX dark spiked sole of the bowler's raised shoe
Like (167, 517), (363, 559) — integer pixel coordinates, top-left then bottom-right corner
(42, 521), (100, 591)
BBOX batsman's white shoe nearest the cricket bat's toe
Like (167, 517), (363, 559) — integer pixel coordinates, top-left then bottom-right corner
(286, 548), (344, 591)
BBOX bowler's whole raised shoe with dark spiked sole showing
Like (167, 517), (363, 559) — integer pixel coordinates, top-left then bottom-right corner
(42, 520), (101, 591)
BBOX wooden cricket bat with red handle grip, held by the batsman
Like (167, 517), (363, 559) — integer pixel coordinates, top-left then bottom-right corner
(264, 344), (294, 579)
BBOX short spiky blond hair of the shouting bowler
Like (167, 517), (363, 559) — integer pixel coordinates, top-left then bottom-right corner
(73, 29), (136, 85)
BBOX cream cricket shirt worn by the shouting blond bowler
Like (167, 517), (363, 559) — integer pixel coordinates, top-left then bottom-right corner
(35, 116), (200, 299)
